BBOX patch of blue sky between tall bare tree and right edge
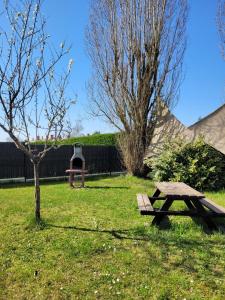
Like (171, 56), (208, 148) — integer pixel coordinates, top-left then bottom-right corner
(177, 0), (225, 125)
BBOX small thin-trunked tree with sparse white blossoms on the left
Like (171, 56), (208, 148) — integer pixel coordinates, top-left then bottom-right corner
(0, 0), (73, 222)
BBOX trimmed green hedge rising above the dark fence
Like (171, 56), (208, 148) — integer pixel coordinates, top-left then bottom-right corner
(34, 133), (117, 146)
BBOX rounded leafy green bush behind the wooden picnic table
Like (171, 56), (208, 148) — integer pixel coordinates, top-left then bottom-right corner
(145, 138), (225, 190)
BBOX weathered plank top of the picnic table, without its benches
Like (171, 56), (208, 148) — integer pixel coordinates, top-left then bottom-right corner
(155, 182), (205, 199)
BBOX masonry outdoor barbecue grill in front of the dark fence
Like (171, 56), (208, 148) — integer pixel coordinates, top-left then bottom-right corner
(66, 143), (88, 187)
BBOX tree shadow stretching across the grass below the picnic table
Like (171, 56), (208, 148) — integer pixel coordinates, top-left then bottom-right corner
(46, 224), (224, 277)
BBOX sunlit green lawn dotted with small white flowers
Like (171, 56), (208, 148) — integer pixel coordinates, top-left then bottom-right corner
(0, 176), (225, 299)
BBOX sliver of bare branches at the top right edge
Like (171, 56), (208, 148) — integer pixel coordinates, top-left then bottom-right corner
(217, 0), (225, 59)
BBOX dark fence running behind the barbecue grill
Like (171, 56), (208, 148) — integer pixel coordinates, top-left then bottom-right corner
(0, 142), (123, 180)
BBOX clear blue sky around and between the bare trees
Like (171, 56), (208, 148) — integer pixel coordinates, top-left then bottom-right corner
(0, 0), (225, 140)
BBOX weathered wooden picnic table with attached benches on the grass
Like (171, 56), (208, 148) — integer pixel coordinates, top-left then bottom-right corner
(137, 182), (225, 230)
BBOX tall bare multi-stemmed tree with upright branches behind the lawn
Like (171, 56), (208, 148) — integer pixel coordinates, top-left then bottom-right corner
(87, 0), (187, 175)
